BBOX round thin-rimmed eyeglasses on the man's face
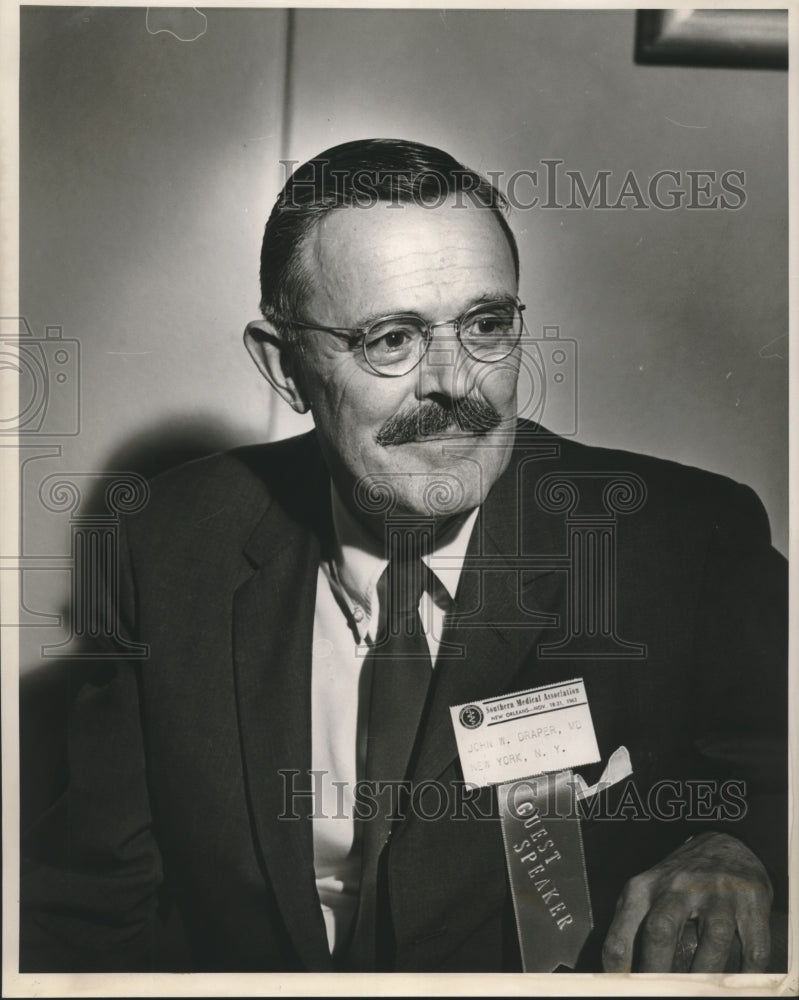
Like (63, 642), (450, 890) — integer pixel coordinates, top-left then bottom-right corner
(288, 299), (525, 378)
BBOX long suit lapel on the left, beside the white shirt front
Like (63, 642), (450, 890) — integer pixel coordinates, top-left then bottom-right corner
(233, 436), (332, 971)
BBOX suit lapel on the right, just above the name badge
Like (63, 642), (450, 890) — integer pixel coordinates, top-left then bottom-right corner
(414, 447), (565, 780)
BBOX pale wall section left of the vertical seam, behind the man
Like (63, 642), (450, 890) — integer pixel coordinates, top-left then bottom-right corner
(20, 7), (288, 666)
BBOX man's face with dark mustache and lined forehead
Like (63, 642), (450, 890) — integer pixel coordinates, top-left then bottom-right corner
(290, 196), (520, 518)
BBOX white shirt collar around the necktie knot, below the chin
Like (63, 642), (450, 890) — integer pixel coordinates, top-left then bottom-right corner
(326, 482), (479, 641)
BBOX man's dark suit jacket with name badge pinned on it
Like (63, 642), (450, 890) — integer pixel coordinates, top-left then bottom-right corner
(22, 424), (787, 971)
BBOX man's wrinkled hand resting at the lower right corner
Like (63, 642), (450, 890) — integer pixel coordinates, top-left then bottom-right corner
(602, 833), (773, 972)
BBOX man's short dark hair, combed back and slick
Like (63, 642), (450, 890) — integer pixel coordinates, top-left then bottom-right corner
(261, 139), (519, 334)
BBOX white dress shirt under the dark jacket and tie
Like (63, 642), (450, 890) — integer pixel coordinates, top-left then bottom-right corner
(311, 489), (478, 954)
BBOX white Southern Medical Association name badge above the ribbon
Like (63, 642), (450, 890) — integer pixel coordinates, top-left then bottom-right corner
(450, 677), (600, 787)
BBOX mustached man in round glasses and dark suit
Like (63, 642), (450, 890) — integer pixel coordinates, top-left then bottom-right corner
(22, 140), (787, 972)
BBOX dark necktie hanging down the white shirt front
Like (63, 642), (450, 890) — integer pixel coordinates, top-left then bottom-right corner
(347, 532), (432, 972)
